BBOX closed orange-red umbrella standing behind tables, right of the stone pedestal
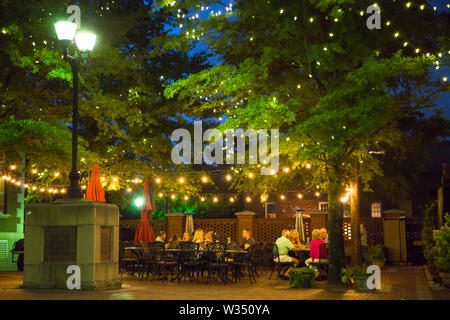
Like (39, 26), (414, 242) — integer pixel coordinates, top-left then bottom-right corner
(134, 178), (156, 242)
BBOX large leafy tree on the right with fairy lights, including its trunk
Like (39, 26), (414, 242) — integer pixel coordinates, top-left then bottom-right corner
(166, 0), (448, 282)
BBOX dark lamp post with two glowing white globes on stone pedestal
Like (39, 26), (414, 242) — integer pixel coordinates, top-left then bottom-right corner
(55, 21), (96, 199)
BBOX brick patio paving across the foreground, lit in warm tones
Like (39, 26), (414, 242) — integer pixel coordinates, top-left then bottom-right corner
(0, 266), (450, 300)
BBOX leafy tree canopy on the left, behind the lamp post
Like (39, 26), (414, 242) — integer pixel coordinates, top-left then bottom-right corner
(0, 0), (208, 200)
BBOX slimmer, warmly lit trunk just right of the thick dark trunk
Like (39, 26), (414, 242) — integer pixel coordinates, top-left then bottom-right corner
(350, 166), (362, 265)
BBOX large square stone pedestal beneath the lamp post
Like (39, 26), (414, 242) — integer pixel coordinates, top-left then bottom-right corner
(23, 200), (121, 290)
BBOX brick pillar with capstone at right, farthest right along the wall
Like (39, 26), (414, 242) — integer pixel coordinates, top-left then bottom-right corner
(383, 210), (407, 262)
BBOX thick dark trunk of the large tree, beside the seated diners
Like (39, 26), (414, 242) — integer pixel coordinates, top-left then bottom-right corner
(328, 178), (345, 284)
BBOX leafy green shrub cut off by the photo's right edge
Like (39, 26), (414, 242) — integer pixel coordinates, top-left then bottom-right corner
(432, 214), (450, 288)
